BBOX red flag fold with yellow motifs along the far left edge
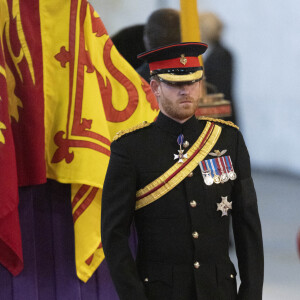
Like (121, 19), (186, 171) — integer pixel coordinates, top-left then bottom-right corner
(0, 1), (23, 275)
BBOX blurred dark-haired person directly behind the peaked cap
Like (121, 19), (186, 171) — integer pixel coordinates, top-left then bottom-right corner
(136, 8), (181, 82)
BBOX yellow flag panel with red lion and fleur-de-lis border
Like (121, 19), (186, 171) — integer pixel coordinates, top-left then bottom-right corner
(40, 0), (157, 281)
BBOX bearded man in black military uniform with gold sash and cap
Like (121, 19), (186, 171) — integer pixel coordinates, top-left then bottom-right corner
(101, 43), (263, 300)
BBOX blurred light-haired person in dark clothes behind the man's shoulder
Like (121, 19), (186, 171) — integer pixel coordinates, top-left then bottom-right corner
(199, 12), (237, 123)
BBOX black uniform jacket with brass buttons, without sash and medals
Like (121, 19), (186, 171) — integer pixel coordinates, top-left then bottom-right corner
(101, 113), (263, 300)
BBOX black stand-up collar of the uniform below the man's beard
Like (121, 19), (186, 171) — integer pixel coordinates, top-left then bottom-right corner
(155, 112), (200, 136)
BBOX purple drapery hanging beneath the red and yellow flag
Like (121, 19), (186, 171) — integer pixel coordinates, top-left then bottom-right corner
(0, 180), (137, 300)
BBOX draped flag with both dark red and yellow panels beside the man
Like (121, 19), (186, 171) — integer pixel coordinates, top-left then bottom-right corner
(0, 0), (158, 281)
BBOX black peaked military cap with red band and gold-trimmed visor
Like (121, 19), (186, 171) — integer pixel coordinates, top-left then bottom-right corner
(137, 42), (207, 83)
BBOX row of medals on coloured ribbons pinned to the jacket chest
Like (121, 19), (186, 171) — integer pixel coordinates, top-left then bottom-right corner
(199, 155), (236, 185)
